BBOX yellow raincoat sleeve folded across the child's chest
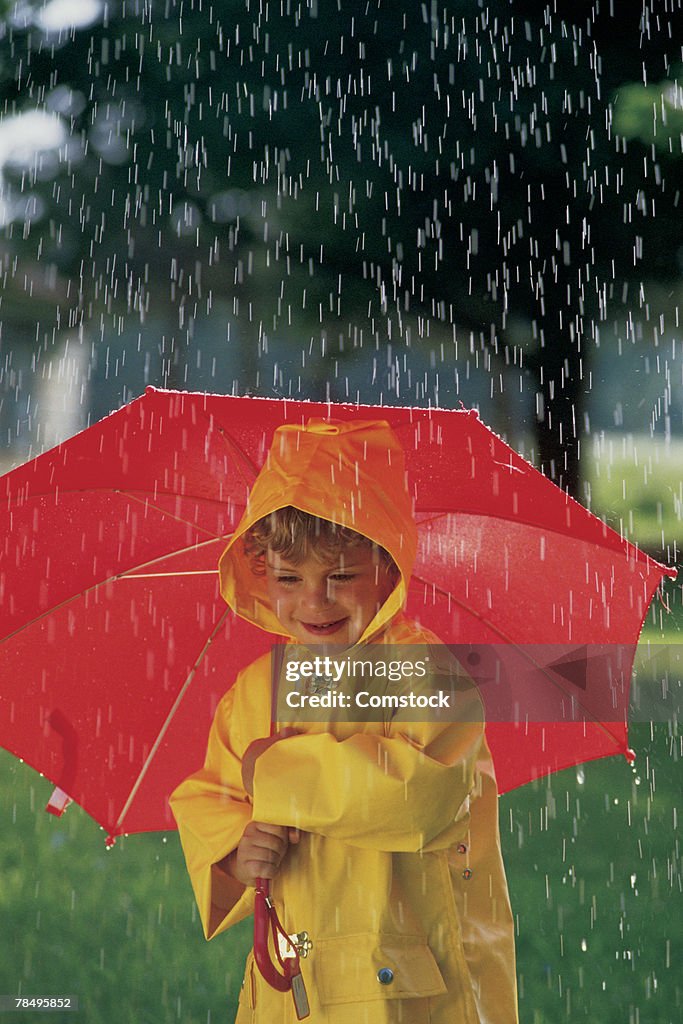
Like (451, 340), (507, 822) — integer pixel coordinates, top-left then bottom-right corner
(254, 659), (483, 853)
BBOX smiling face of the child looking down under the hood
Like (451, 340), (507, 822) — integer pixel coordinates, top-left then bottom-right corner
(265, 547), (394, 647)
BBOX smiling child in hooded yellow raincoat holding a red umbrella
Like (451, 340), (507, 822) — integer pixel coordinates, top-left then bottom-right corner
(171, 421), (517, 1024)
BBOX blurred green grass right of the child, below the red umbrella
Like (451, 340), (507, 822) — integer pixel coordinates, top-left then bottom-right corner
(501, 724), (683, 1024)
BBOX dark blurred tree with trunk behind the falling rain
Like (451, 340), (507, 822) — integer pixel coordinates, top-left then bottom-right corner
(0, 0), (680, 494)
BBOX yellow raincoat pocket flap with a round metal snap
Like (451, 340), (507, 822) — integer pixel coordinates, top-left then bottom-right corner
(314, 934), (446, 1006)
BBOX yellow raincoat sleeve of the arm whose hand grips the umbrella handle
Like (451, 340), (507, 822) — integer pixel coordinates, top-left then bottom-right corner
(170, 684), (254, 939)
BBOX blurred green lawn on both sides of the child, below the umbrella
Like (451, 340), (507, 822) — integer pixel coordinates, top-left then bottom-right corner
(0, 725), (683, 1024)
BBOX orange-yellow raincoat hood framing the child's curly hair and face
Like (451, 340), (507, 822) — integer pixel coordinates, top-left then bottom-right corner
(218, 419), (417, 642)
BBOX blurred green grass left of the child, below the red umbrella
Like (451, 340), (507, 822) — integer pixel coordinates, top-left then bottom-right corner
(0, 751), (249, 1024)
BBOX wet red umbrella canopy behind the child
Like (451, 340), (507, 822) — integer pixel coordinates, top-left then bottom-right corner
(0, 388), (673, 838)
